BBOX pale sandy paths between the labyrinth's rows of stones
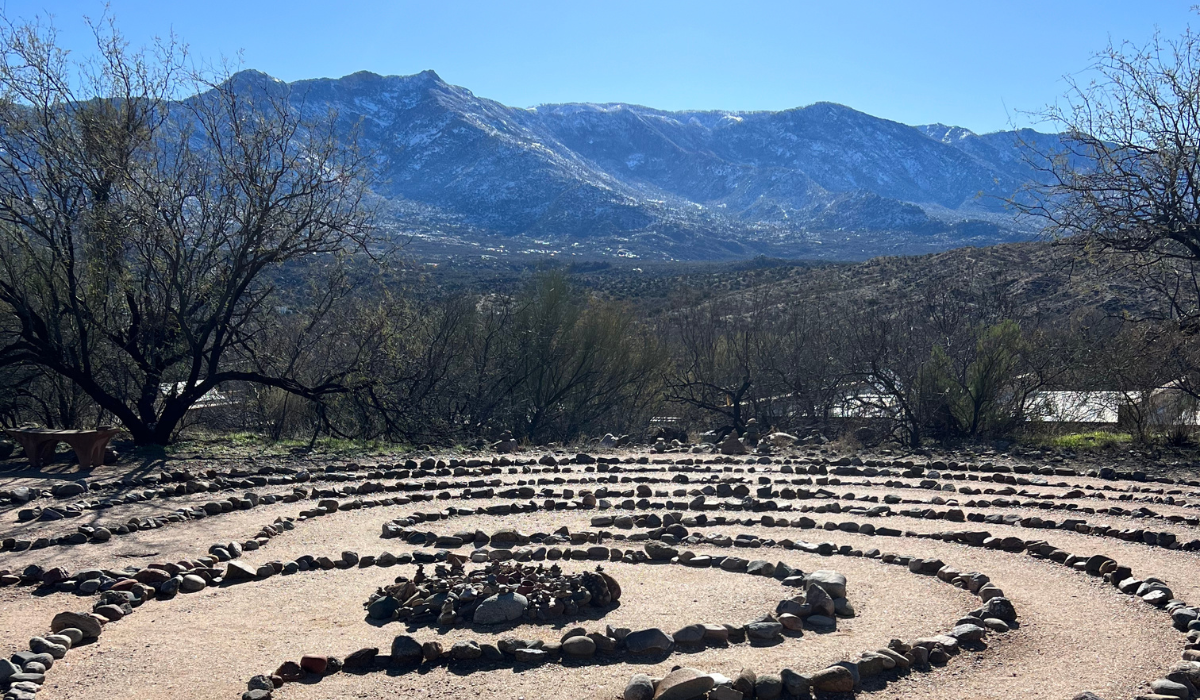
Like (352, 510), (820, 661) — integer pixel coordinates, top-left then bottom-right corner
(0, 449), (1200, 700)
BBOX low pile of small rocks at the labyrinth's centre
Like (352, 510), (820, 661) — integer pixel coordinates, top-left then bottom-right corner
(364, 556), (620, 627)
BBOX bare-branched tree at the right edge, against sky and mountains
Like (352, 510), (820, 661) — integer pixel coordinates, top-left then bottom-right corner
(1012, 21), (1200, 325)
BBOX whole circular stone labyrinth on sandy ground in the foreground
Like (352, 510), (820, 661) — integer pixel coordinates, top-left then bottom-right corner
(0, 450), (1200, 700)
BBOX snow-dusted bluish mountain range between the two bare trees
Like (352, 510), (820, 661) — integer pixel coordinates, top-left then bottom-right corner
(233, 71), (1055, 259)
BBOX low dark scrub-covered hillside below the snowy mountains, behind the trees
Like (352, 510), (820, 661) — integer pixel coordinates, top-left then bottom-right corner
(413, 241), (1159, 322)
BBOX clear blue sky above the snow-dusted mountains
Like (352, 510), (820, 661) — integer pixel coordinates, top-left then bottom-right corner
(4, 0), (1200, 132)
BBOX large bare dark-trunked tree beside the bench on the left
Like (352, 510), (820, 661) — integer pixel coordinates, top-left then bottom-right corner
(0, 16), (368, 443)
